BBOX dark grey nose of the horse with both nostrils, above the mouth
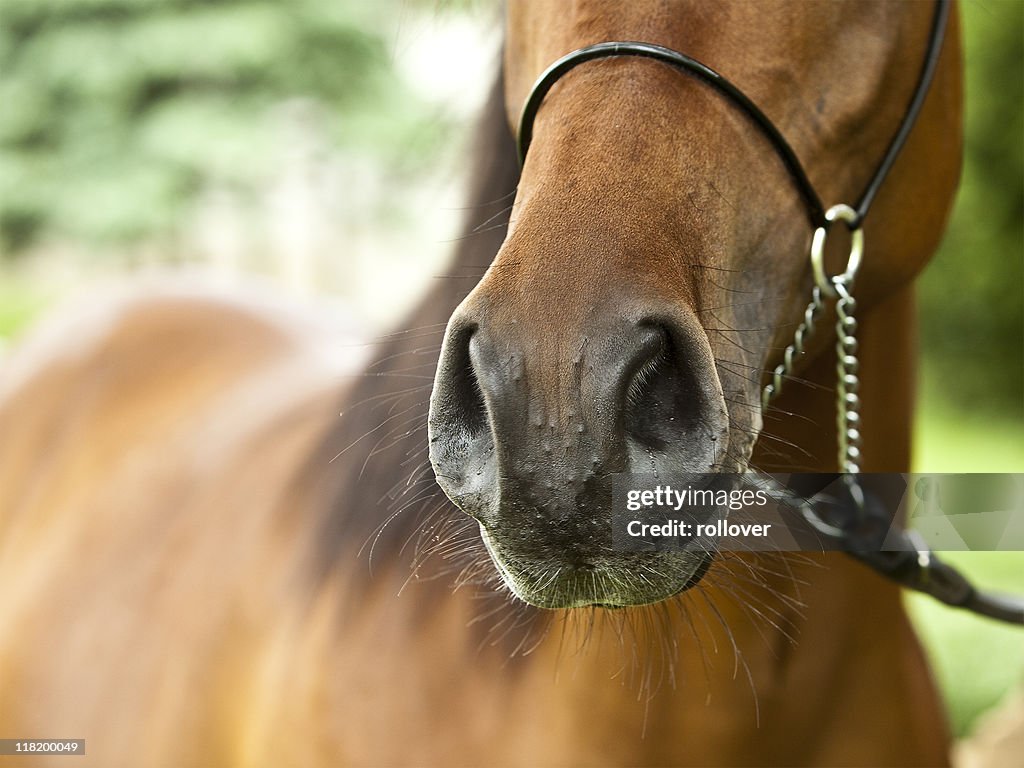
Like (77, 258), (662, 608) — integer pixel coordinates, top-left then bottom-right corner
(429, 310), (728, 519)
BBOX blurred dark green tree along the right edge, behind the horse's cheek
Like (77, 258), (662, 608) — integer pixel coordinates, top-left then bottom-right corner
(921, 0), (1024, 415)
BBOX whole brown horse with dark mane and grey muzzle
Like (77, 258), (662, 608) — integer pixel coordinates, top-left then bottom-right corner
(0, 0), (961, 766)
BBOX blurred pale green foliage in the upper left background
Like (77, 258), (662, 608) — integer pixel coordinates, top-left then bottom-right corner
(0, 0), (442, 253)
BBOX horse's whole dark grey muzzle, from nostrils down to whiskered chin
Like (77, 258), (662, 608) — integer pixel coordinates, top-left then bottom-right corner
(429, 302), (729, 607)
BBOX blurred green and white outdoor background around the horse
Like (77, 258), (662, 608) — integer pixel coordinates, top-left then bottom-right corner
(0, 0), (1024, 734)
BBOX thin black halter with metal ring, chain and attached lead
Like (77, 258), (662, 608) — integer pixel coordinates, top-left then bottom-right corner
(518, 0), (1024, 624)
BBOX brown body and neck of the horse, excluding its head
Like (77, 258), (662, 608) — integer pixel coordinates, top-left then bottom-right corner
(0, 3), (958, 767)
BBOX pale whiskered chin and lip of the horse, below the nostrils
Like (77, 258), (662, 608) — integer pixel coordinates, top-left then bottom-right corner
(480, 525), (714, 609)
